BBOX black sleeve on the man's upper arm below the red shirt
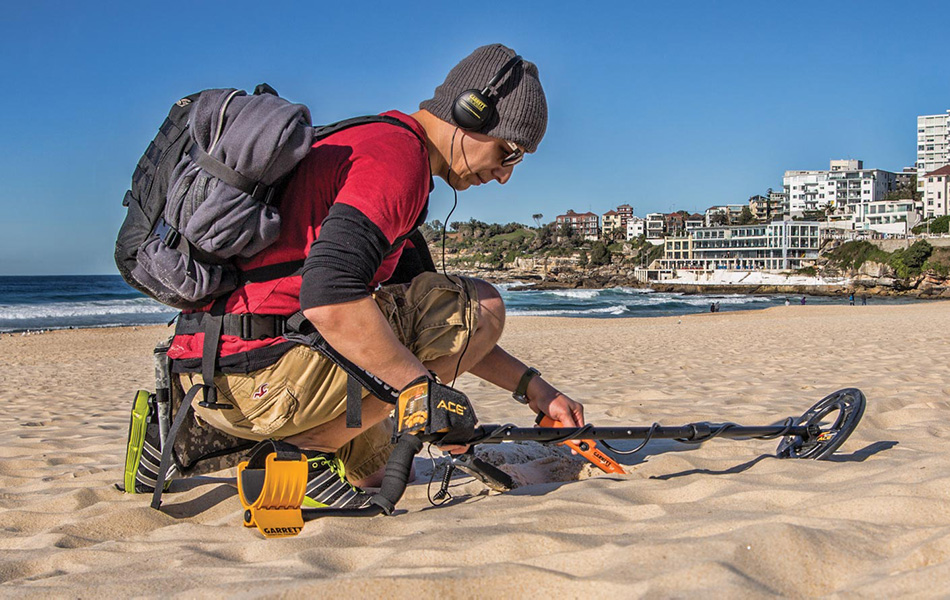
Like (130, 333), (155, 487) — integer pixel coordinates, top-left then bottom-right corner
(300, 203), (391, 310)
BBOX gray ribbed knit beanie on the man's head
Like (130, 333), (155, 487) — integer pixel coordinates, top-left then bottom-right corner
(419, 44), (548, 152)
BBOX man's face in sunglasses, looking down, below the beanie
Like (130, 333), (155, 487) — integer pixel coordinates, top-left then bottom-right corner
(449, 130), (517, 191)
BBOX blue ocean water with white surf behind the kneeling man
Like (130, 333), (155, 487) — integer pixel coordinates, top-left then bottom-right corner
(0, 275), (913, 332)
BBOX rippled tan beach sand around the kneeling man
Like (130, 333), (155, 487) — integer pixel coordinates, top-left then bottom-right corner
(0, 302), (950, 598)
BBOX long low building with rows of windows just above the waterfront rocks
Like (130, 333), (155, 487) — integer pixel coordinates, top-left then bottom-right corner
(657, 221), (820, 270)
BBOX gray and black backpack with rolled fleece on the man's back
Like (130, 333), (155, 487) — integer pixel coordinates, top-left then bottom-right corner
(115, 84), (414, 309)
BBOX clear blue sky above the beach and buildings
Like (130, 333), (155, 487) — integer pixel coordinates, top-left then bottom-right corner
(0, 0), (950, 275)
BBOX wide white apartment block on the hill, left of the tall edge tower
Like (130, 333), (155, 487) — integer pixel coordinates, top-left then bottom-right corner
(782, 159), (897, 217)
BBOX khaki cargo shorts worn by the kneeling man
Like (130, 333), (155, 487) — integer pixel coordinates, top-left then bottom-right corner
(181, 273), (478, 480)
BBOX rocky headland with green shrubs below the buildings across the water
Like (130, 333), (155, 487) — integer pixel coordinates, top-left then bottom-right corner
(430, 224), (950, 298)
